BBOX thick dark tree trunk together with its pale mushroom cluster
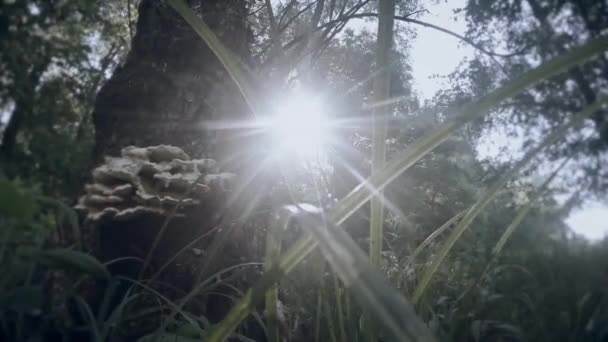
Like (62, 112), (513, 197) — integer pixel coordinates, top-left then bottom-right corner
(79, 0), (258, 331)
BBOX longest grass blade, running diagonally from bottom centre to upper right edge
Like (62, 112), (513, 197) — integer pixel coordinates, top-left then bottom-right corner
(189, 30), (608, 342)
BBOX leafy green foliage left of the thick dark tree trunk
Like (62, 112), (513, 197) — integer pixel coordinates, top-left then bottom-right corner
(0, 0), (124, 198)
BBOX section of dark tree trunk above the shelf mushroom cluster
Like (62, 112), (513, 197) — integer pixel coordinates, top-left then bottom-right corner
(93, 0), (250, 160)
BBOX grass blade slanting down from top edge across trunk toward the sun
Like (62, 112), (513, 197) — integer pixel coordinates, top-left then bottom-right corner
(167, 0), (261, 115)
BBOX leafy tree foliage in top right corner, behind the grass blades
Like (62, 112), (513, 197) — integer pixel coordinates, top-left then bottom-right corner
(454, 0), (608, 194)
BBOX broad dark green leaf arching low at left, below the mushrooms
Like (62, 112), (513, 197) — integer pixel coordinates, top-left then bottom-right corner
(35, 248), (111, 279)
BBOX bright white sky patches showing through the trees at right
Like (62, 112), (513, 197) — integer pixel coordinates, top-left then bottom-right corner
(411, 0), (608, 240)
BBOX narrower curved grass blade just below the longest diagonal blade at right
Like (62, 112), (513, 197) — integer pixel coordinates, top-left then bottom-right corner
(412, 97), (608, 304)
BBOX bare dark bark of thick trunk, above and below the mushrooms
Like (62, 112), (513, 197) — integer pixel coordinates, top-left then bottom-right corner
(78, 0), (258, 336)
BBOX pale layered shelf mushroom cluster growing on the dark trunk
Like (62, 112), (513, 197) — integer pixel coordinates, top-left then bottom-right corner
(76, 145), (235, 224)
